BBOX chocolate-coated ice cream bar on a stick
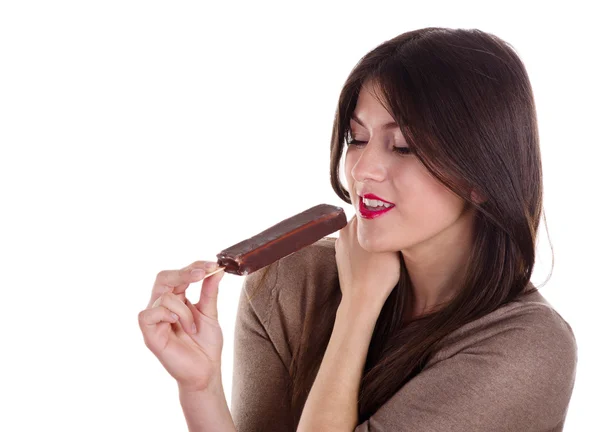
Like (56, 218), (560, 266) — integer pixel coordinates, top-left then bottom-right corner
(217, 204), (347, 275)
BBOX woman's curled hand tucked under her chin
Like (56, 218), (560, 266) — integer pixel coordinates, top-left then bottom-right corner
(335, 215), (400, 312)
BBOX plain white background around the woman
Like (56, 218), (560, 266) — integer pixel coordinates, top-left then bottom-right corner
(0, 0), (600, 431)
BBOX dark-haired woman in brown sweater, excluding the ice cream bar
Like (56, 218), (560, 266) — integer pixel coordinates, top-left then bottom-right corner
(139, 28), (577, 432)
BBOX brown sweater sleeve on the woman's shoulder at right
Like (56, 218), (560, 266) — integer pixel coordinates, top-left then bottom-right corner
(355, 305), (577, 432)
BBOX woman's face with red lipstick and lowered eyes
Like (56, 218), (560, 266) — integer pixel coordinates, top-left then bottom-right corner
(344, 83), (468, 252)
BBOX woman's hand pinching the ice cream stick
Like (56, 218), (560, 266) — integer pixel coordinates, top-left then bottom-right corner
(138, 261), (224, 391)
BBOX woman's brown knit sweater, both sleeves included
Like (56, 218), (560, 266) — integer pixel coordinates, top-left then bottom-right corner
(231, 238), (577, 432)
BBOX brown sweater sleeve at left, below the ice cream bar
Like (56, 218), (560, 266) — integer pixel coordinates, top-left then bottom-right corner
(231, 270), (293, 432)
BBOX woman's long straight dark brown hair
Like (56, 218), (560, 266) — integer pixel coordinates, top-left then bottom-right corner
(264, 28), (542, 424)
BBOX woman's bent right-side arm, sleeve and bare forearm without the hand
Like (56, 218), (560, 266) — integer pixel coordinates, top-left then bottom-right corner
(298, 300), (577, 432)
